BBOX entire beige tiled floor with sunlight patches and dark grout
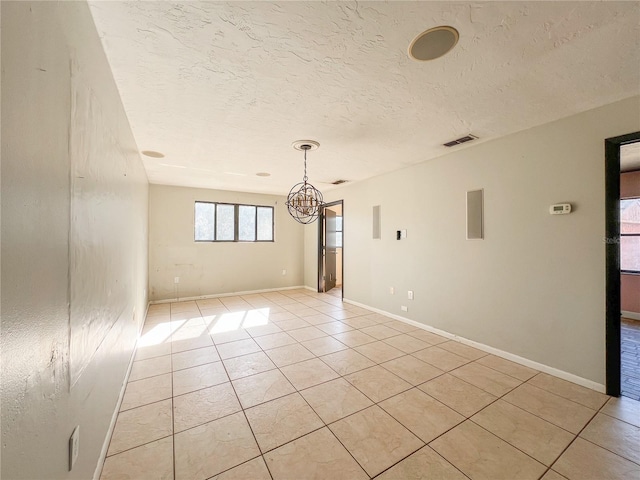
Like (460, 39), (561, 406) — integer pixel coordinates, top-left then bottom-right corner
(102, 290), (640, 480)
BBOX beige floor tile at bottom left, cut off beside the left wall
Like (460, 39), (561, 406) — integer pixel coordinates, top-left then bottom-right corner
(100, 437), (173, 480)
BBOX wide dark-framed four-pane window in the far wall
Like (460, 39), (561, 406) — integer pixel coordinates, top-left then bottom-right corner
(194, 202), (273, 242)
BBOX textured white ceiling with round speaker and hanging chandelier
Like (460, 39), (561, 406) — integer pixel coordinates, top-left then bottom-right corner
(90, 1), (640, 194)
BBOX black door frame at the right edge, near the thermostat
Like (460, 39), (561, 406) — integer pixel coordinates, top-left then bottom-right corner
(604, 132), (640, 397)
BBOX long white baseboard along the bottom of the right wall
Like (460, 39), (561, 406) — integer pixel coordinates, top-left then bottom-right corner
(343, 298), (606, 393)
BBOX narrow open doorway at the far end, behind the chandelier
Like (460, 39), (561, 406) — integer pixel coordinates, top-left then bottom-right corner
(318, 200), (344, 299)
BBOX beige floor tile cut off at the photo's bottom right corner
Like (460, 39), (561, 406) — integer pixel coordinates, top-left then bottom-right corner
(553, 438), (640, 480)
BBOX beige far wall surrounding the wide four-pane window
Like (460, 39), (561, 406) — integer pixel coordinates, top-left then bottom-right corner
(149, 185), (304, 300)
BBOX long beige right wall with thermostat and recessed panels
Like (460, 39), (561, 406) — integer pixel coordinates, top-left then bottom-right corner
(305, 97), (640, 384)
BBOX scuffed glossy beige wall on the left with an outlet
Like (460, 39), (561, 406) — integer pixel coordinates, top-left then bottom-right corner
(1, 2), (148, 479)
